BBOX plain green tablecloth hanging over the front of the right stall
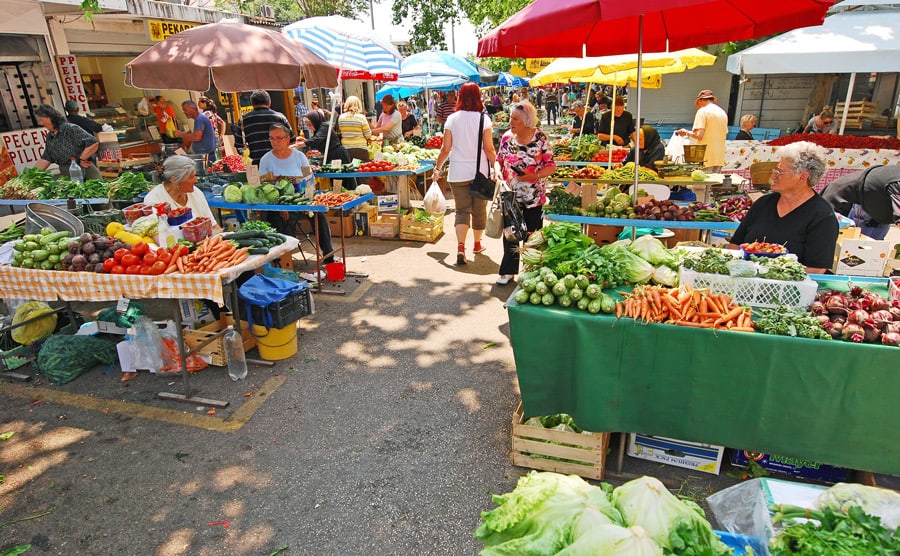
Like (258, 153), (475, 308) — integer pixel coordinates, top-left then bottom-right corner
(508, 288), (900, 475)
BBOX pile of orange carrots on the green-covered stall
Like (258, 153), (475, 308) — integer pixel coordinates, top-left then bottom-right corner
(616, 286), (753, 332)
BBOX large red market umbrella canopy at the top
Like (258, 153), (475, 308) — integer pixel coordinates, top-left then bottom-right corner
(478, 0), (834, 58)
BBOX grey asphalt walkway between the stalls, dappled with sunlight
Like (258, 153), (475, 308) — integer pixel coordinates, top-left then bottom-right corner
(0, 201), (872, 556)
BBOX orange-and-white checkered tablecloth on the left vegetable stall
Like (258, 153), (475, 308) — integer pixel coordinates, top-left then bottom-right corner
(0, 236), (299, 304)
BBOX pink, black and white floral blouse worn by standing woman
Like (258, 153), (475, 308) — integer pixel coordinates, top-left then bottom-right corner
(497, 129), (554, 208)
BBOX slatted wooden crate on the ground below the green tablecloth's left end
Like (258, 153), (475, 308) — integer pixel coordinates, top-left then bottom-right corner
(510, 402), (610, 480)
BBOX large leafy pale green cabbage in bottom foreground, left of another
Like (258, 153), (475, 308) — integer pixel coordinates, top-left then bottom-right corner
(475, 471), (622, 556)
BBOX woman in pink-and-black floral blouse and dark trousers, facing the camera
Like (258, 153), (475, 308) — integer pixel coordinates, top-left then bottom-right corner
(497, 101), (556, 286)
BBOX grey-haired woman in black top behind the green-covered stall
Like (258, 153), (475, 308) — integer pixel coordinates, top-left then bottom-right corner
(729, 141), (838, 274)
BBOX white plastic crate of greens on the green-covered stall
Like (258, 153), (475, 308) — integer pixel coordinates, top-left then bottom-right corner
(679, 267), (819, 308)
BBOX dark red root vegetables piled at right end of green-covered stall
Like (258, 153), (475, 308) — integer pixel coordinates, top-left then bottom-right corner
(810, 286), (900, 346)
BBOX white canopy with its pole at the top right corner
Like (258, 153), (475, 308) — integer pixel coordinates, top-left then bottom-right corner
(726, 8), (900, 134)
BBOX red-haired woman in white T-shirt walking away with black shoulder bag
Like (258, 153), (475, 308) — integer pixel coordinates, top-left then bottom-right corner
(434, 83), (496, 265)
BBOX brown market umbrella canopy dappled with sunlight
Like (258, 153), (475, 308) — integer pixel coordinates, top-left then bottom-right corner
(125, 21), (337, 92)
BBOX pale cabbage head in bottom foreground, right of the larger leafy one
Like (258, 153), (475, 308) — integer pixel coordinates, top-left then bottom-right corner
(612, 477), (733, 556)
